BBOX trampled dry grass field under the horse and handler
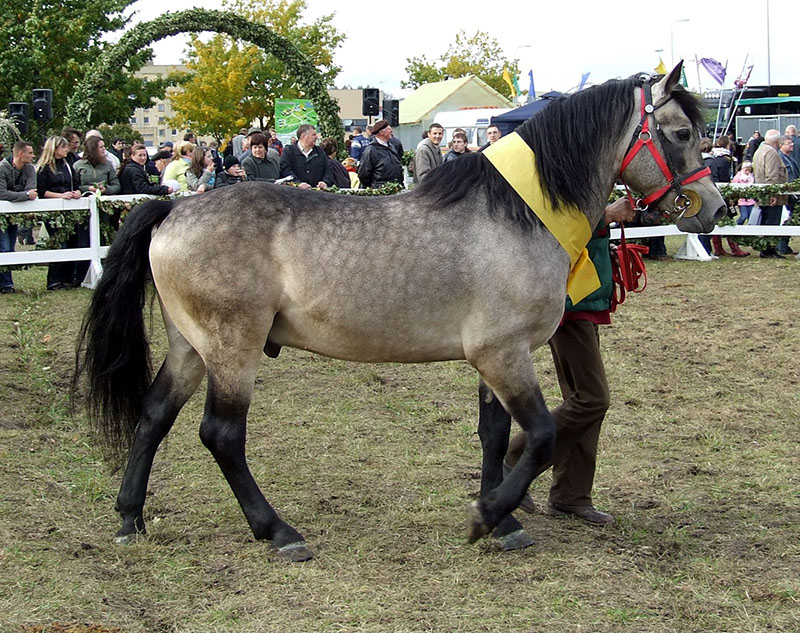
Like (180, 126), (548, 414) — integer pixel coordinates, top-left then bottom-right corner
(0, 242), (800, 633)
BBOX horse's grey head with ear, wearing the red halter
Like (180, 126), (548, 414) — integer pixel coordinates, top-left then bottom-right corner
(620, 61), (726, 233)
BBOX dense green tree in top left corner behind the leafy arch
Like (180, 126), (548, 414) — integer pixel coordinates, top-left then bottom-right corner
(0, 0), (164, 129)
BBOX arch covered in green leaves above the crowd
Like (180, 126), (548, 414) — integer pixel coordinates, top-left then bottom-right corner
(66, 9), (344, 138)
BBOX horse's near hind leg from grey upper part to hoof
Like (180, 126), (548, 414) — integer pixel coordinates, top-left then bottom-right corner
(200, 349), (312, 562)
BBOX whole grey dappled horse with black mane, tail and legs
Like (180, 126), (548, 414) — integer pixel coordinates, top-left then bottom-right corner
(75, 64), (725, 560)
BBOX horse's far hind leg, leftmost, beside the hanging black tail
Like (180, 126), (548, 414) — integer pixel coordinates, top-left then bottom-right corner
(115, 328), (205, 543)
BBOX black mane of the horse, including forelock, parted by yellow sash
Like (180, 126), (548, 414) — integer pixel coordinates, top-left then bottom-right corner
(412, 75), (703, 226)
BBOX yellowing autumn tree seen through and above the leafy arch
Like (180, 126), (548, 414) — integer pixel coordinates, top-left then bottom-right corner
(173, 0), (345, 136)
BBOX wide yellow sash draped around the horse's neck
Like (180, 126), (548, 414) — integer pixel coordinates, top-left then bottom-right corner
(483, 132), (600, 305)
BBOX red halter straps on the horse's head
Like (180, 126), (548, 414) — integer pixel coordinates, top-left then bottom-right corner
(619, 81), (711, 209)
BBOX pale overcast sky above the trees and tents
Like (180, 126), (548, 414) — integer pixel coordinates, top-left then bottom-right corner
(125, 0), (800, 97)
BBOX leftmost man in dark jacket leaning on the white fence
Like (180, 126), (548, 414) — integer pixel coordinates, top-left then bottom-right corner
(0, 141), (38, 294)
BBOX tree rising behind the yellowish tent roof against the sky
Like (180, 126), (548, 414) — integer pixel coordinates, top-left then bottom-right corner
(400, 31), (519, 95)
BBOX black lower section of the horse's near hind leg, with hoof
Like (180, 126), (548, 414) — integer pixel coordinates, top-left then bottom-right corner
(200, 371), (312, 561)
